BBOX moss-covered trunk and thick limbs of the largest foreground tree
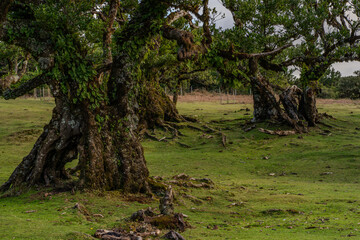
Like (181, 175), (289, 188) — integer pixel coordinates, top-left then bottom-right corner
(0, 0), (171, 194)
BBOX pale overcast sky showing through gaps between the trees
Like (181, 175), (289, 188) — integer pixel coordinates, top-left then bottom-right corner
(209, 0), (360, 76)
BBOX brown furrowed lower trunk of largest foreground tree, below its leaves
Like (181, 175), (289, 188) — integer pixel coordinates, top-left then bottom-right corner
(0, 77), (149, 195)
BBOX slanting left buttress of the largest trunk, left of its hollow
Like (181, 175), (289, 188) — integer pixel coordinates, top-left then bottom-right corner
(0, 81), (81, 194)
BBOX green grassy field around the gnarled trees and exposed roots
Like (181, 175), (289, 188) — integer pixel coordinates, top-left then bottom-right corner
(0, 100), (360, 240)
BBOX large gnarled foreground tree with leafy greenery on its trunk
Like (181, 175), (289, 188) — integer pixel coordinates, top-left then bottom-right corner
(0, 0), (190, 194)
